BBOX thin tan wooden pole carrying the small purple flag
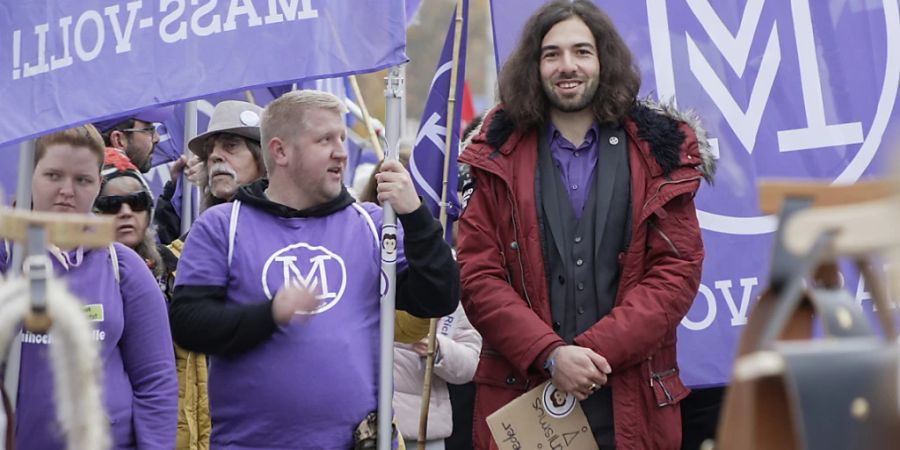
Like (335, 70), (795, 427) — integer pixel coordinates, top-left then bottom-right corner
(418, 0), (465, 450)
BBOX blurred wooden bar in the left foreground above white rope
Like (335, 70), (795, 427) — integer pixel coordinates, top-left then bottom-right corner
(0, 207), (116, 248)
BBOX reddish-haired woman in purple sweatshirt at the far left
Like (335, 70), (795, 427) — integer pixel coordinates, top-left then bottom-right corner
(0, 125), (178, 450)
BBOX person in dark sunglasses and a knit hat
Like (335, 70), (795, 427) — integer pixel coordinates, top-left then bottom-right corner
(94, 148), (178, 294)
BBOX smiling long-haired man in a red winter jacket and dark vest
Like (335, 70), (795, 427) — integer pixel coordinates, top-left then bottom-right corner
(458, 0), (714, 449)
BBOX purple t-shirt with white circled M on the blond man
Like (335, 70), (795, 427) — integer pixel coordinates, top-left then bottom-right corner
(175, 203), (405, 450)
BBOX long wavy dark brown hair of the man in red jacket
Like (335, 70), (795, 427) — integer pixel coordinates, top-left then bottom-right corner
(499, 0), (641, 129)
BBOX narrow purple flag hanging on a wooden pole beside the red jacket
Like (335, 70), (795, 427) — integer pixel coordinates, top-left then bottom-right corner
(409, 0), (469, 230)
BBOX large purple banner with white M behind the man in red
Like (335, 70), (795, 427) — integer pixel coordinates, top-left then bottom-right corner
(491, 0), (900, 387)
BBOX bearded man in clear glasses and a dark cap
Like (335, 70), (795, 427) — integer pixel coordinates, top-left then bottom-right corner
(94, 106), (174, 173)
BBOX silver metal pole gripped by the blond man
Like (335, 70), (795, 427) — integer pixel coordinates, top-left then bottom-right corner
(378, 67), (404, 450)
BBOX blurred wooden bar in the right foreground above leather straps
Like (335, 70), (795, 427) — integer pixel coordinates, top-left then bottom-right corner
(759, 179), (900, 214)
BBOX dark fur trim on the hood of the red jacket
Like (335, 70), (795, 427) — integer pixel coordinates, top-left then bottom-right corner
(462, 98), (716, 184)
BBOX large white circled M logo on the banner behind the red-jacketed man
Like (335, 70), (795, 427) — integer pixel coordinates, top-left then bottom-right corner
(647, 0), (900, 235)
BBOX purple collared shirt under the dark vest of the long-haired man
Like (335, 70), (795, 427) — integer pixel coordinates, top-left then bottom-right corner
(550, 123), (600, 220)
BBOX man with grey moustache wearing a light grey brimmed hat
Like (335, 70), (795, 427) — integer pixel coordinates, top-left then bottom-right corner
(156, 100), (266, 243)
